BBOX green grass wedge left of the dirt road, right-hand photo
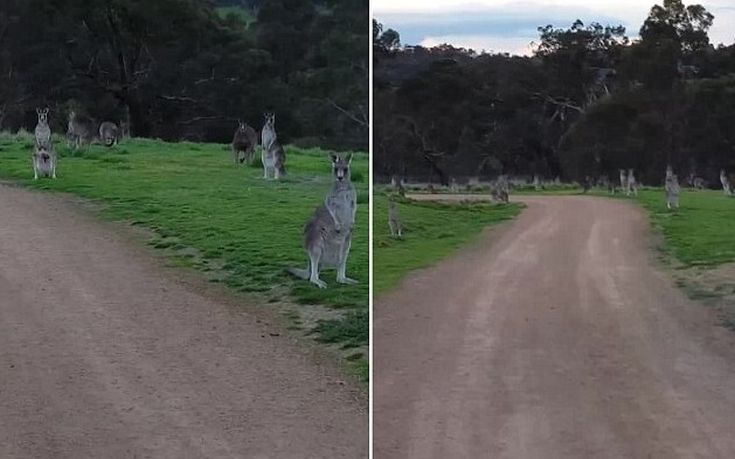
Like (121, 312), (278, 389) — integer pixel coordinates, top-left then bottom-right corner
(373, 195), (521, 297)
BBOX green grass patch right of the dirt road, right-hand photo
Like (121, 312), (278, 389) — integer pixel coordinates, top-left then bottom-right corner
(637, 189), (735, 267)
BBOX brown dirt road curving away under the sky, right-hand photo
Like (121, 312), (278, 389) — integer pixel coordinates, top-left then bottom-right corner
(374, 197), (735, 459)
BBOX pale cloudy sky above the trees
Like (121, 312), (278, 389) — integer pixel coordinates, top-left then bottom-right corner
(372, 0), (735, 55)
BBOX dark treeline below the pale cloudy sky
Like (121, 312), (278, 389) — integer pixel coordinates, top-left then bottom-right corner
(373, 0), (735, 185)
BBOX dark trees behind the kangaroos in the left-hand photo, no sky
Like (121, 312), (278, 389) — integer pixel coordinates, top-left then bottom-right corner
(0, 0), (369, 149)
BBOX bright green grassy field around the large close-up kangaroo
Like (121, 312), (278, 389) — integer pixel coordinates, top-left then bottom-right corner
(0, 134), (369, 378)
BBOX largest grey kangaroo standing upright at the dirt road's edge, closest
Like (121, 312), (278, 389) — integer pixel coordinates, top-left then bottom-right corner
(288, 153), (357, 288)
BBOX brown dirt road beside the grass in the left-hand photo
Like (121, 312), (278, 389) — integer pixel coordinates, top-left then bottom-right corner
(0, 185), (368, 459)
